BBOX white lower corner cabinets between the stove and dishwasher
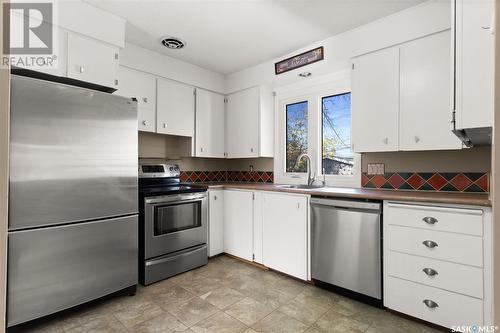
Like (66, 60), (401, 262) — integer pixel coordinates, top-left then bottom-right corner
(218, 190), (309, 280)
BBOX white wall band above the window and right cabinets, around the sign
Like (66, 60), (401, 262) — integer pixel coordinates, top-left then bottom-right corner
(226, 0), (451, 93)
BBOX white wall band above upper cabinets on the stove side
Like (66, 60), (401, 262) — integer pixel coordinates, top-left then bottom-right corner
(120, 43), (225, 93)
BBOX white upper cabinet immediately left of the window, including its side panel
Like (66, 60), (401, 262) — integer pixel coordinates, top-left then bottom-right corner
(226, 87), (274, 158)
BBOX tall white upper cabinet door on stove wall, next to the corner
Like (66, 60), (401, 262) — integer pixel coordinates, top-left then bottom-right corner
(195, 89), (225, 158)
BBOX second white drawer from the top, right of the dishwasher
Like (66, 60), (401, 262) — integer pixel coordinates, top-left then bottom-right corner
(386, 225), (483, 267)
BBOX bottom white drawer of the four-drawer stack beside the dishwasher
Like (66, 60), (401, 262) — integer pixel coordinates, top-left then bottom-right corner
(384, 277), (483, 328)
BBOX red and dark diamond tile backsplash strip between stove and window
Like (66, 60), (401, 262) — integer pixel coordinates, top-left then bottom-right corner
(180, 171), (274, 183)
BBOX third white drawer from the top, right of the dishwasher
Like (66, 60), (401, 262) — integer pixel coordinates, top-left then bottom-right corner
(387, 251), (483, 298)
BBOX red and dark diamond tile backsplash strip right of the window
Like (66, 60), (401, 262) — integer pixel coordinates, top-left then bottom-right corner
(361, 172), (489, 193)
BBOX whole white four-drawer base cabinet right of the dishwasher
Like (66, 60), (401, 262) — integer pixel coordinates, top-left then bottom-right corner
(384, 202), (492, 328)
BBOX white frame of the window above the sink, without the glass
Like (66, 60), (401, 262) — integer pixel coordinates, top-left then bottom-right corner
(274, 71), (361, 187)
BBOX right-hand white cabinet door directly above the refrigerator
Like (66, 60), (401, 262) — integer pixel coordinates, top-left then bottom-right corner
(67, 33), (118, 89)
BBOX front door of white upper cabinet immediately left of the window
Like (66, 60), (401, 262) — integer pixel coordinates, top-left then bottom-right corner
(226, 87), (260, 158)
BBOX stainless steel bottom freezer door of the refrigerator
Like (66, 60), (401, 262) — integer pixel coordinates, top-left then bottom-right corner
(7, 216), (138, 327)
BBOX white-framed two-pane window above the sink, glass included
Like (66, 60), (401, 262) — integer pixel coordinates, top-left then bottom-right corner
(274, 73), (361, 187)
